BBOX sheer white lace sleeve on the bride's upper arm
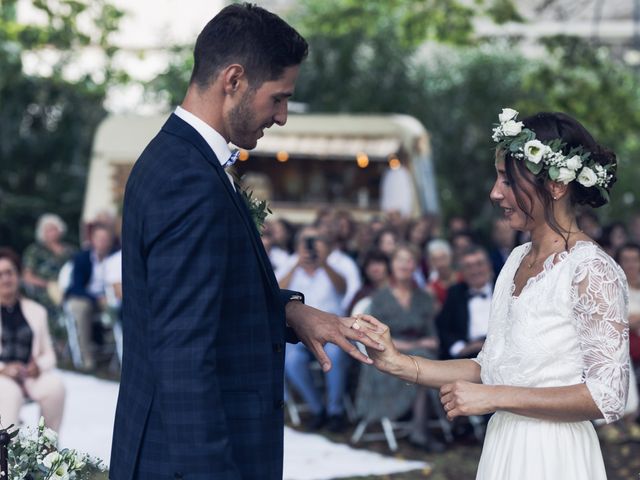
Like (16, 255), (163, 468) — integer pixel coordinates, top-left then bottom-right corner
(572, 251), (629, 423)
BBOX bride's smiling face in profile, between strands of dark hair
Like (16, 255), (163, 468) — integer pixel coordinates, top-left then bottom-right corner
(489, 153), (544, 231)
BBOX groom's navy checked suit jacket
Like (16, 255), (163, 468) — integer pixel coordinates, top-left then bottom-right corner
(110, 115), (298, 480)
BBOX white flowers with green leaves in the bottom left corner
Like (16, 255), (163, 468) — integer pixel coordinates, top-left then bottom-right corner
(0, 417), (106, 480)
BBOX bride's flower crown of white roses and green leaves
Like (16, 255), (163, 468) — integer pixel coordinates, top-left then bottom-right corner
(492, 108), (615, 200)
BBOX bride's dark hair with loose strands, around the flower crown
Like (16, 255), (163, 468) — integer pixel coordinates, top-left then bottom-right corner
(504, 112), (617, 242)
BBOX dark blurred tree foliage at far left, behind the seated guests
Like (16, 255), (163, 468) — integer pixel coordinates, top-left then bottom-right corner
(0, 0), (125, 250)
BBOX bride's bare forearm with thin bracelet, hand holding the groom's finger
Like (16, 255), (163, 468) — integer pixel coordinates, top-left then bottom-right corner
(356, 315), (480, 388)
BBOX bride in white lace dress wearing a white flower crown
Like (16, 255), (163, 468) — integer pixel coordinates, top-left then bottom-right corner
(354, 109), (629, 480)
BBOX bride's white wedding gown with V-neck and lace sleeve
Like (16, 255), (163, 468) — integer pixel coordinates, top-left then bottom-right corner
(476, 242), (629, 480)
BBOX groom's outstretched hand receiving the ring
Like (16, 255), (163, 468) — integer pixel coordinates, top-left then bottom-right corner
(286, 302), (384, 372)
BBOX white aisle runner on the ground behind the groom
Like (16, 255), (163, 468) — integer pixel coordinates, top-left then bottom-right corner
(22, 372), (427, 480)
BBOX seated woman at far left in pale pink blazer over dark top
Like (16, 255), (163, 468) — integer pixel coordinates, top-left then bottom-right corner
(0, 248), (65, 431)
